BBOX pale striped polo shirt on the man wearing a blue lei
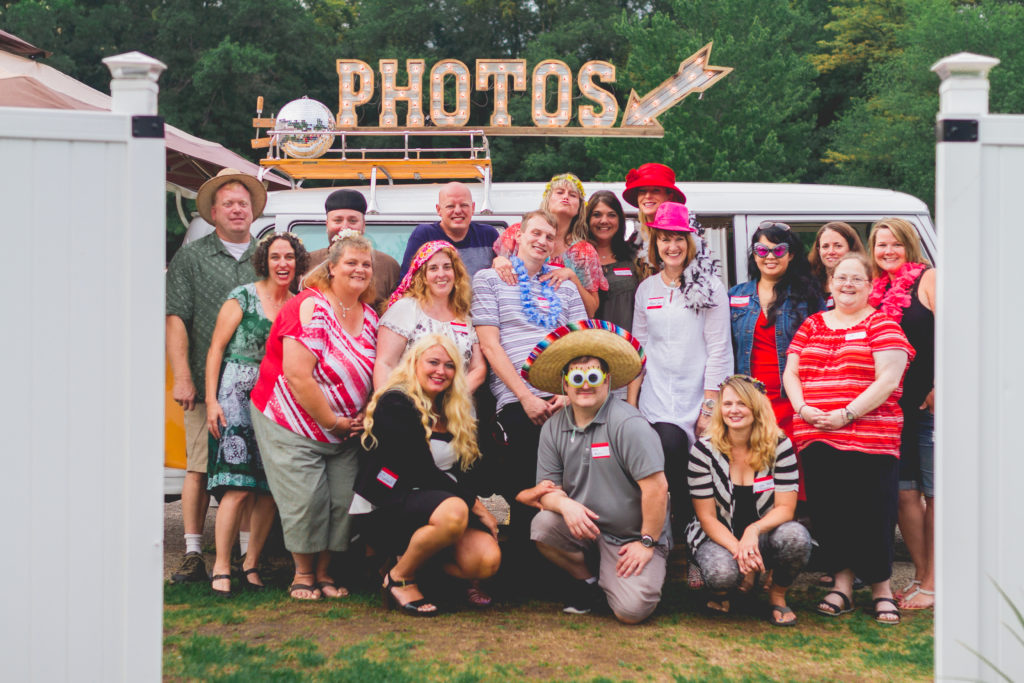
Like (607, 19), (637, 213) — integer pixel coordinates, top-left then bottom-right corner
(471, 266), (587, 411)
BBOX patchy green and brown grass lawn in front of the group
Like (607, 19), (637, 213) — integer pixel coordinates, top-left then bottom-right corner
(164, 574), (934, 683)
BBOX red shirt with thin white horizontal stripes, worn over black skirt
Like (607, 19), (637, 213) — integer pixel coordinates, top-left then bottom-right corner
(788, 311), (914, 458)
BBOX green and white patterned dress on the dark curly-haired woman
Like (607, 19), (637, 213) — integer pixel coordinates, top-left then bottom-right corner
(207, 283), (270, 501)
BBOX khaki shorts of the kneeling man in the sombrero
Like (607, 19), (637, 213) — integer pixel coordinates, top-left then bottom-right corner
(529, 510), (669, 623)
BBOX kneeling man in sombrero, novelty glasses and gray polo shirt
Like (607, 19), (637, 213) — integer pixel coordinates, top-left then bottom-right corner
(517, 321), (672, 624)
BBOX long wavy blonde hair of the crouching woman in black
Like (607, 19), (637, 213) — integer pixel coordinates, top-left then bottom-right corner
(362, 335), (480, 472)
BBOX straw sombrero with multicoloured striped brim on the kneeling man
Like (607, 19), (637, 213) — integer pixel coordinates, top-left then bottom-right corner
(520, 319), (647, 393)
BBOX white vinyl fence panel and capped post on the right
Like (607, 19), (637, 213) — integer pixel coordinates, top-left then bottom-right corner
(932, 53), (1024, 681)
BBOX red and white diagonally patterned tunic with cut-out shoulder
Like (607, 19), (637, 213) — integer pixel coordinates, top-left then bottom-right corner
(252, 289), (377, 443)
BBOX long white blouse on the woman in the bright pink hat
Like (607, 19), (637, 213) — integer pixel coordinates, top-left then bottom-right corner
(633, 273), (732, 444)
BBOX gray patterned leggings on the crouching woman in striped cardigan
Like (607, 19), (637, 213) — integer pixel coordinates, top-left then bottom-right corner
(693, 521), (811, 591)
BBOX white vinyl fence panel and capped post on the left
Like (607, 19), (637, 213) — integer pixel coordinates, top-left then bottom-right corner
(0, 53), (165, 682)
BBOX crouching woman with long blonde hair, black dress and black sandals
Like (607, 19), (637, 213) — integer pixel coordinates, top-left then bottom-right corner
(350, 335), (501, 616)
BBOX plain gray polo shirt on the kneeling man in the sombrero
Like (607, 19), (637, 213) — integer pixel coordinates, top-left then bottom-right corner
(537, 396), (671, 546)
